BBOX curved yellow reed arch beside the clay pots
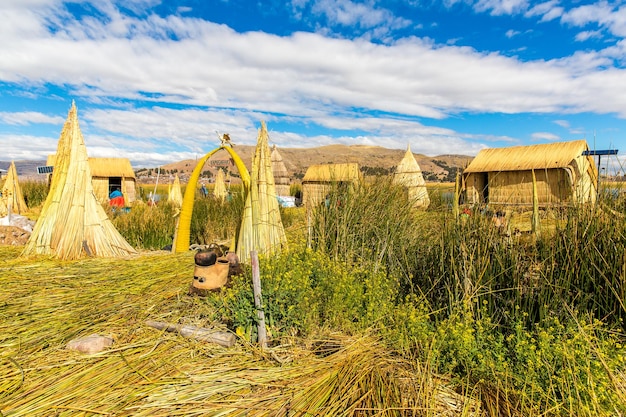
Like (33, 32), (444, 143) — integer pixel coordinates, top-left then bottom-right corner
(172, 145), (250, 252)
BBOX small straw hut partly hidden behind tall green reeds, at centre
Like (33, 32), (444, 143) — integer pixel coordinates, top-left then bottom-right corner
(302, 163), (361, 207)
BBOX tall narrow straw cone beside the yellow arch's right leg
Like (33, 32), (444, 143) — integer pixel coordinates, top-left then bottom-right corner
(237, 122), (287, 262)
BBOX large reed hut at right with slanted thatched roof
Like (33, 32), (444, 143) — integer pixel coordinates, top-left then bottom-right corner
(462, 140), (598, 206)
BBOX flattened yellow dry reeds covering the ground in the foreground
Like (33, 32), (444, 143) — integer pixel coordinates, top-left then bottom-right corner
(0, 246), (471, 416)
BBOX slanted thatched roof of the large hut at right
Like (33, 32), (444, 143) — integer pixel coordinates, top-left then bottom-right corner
(464, 140), (591, 173)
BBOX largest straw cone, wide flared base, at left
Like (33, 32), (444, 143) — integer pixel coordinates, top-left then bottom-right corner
(23, 103), (136, 259)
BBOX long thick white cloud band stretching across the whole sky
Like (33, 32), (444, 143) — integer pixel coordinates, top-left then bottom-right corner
(0, 2), (626, 118)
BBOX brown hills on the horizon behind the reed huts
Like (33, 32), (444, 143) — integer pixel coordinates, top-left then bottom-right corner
(0, 145), (472, 181)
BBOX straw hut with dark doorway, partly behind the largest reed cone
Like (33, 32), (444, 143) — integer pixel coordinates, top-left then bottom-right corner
(47, 155), (137, 204)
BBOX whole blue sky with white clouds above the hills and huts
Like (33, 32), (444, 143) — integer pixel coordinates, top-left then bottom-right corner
(0, 0), (626, 171)
